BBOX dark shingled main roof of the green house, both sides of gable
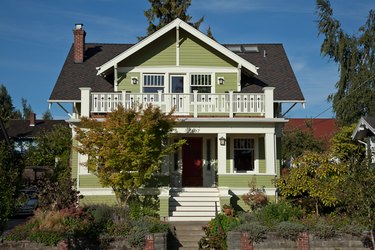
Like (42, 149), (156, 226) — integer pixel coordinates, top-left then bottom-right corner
(49, 43), (304, 102)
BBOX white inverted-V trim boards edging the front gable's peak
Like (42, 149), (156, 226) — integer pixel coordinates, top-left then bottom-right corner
(97, 18), (258, 75)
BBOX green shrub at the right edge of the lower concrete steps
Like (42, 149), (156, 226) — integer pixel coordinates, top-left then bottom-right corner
(198, 214), (240, 249)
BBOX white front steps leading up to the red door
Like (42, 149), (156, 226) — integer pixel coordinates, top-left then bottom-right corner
(169, 188), (220, 222)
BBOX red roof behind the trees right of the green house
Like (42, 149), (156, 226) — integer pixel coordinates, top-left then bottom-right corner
(284, 118), (339, 142)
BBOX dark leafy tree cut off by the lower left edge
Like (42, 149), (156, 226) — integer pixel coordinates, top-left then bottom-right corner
(0, 140), (22, 232)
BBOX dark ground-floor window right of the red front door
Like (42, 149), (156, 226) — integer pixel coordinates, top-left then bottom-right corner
(234, 138), (254, 172)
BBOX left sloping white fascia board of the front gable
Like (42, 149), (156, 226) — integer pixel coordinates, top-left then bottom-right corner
(96, 18), (182, 75)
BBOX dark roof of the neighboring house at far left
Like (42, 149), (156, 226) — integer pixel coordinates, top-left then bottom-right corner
(5, 120), (69, 138)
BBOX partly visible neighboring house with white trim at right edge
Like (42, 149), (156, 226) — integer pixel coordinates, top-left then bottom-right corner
(352, 116), (375, 164)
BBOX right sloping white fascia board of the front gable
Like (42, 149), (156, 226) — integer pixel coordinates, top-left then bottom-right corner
(180, 21), (258, 75)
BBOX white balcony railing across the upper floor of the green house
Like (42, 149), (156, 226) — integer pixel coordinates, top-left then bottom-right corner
(90, 92), (266, 117)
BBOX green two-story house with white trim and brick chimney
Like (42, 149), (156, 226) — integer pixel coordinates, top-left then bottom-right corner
(49, 19), (304, 220)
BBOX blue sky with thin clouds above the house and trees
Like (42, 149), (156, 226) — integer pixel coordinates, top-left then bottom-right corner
(0, 0), (375, 119)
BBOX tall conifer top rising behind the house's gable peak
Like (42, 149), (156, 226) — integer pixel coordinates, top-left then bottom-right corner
(144, 0), (204, 35)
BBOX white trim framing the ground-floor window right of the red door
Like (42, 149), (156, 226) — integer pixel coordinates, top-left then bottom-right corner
(230, 135), (259, 175)
